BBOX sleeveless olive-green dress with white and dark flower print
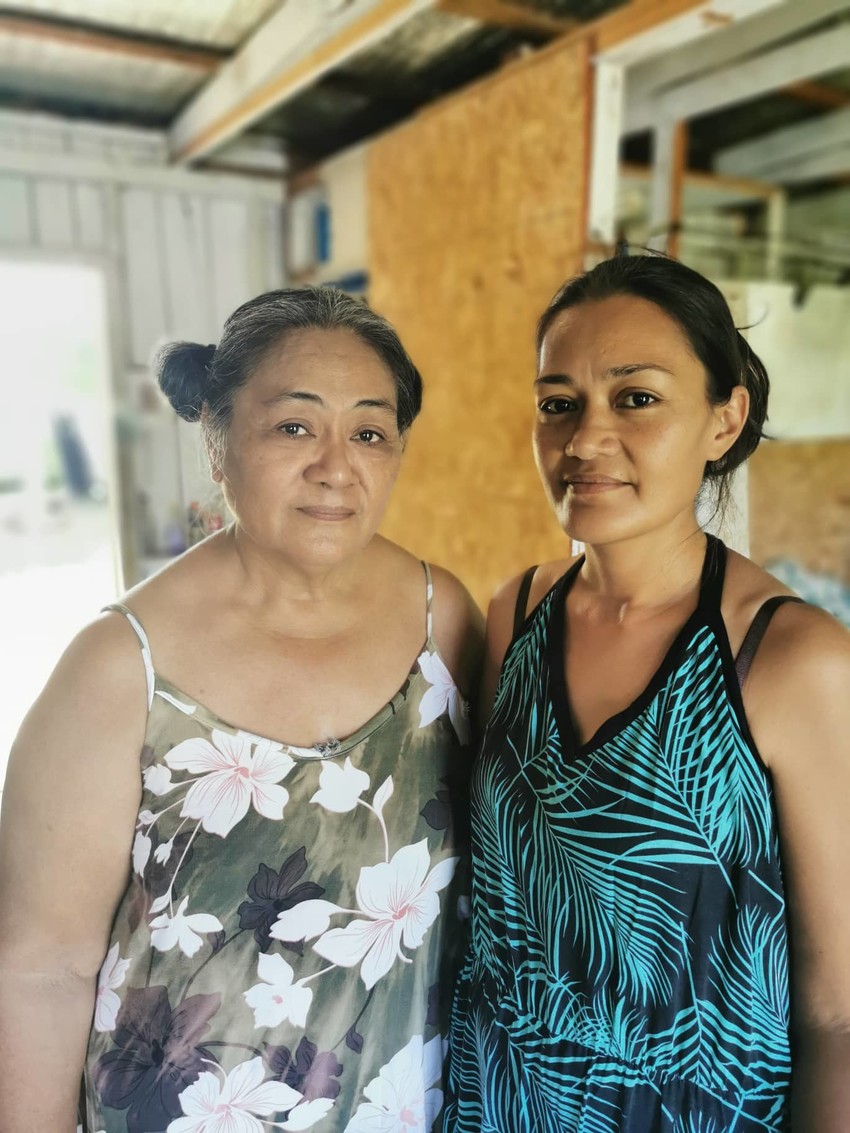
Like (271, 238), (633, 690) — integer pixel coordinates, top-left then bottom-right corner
(80, 567), (469, 1133)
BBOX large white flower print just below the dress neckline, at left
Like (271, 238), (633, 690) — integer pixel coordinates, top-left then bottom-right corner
(165, 729), (295, 837)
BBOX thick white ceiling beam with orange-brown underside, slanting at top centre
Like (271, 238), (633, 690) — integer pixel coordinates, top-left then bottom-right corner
(169, 0), (433, 162)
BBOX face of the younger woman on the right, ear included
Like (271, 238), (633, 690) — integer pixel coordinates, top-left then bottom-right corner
(534, 295), (748, 545)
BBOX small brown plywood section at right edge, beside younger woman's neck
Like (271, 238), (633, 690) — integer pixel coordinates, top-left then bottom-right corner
(749, 440), (850, 585)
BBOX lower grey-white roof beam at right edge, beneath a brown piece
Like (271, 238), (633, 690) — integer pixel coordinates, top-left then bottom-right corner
(715, 107), (850, 180)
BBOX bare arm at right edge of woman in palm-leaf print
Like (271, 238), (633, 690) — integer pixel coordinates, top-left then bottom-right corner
(745, 606), (850, 1133)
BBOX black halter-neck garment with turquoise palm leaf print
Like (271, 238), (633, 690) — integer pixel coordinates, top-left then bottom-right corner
(443, 538), (790, 1133)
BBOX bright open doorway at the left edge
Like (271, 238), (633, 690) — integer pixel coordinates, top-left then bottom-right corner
(0, 259), (118, 791)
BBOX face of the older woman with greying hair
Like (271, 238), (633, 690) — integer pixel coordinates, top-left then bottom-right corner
(221, 330), (402, 568)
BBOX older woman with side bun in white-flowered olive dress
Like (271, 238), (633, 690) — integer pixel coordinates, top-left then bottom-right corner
(0, 289), (479, 1133)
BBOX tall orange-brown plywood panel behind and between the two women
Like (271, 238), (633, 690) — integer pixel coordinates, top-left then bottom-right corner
(367, 41), (589, 604)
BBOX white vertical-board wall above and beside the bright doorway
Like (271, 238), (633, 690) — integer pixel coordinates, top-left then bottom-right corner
(0, 114), (283, 581)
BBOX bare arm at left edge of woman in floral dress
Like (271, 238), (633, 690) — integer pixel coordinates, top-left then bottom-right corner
(0, 614), (146, 1133)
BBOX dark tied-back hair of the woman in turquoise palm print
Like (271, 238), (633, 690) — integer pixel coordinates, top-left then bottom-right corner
(537, 254), (771, 508)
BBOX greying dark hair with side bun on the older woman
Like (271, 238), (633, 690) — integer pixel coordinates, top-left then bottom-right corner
(154, 287), (422, 466)
